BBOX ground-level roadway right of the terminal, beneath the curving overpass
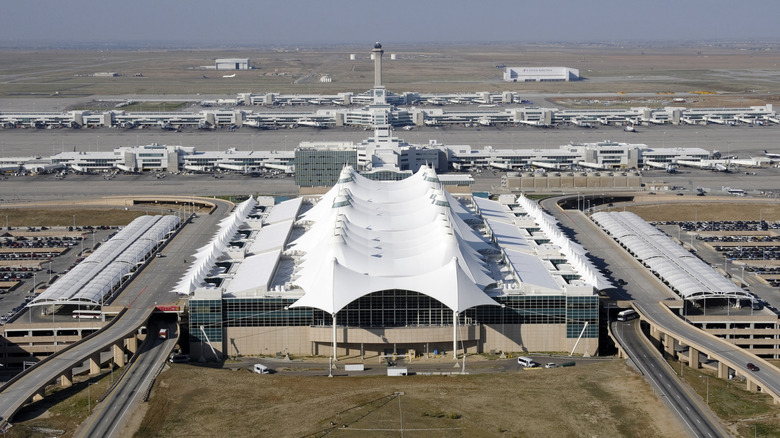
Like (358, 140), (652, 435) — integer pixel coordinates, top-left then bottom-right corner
(610, 320), (729, 438)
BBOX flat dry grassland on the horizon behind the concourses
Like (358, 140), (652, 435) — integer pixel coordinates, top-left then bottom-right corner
(0, 43), (780, 100)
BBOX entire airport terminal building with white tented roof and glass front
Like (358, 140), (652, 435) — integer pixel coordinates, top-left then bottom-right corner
(184, 166), (610, 359)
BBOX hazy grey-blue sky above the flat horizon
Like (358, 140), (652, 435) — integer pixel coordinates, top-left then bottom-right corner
(0, 0), (780, 47)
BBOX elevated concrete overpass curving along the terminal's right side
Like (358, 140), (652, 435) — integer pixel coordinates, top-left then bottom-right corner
(542, 194), (780, 403)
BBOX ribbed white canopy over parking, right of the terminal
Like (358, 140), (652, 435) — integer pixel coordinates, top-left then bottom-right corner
(591, 212), (751, 299)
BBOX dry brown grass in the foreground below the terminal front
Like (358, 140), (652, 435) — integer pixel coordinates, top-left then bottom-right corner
(136, 360), (684, 437)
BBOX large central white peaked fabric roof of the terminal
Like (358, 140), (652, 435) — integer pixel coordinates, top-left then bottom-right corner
(287, 166), (498, 313)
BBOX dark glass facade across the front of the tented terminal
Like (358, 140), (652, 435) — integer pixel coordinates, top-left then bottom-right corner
(195, 290), (599, 342)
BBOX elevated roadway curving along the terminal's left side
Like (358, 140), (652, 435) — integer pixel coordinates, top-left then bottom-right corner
(0, 200), (232, 419)
